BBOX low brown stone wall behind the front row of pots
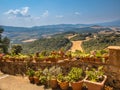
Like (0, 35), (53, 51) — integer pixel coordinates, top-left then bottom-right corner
(0, 59), (107, 75)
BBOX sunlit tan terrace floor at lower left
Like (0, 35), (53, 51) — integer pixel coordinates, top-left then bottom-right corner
(0, 73), (47, 90)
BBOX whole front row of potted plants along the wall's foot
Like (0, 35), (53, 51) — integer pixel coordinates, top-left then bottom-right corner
(27, 66), (107, 90)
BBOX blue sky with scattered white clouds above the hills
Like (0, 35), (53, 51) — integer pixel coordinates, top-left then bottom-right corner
(0, 0), (120, 27)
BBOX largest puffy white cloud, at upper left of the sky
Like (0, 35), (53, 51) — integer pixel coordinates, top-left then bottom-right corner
(5, 7), (30, 17)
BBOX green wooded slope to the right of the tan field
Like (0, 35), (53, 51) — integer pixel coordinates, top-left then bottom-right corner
(82, 34), (120, 52)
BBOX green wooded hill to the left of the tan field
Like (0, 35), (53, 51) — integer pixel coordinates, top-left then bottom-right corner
(22, 37), (72, 53)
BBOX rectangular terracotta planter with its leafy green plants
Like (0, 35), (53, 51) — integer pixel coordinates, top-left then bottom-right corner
(84, 66), (107, 90)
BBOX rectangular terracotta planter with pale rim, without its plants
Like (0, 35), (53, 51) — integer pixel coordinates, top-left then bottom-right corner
(84, 76), (107, 90)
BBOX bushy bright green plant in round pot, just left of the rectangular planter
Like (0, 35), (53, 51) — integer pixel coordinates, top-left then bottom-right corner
(68, 67), (83, 90)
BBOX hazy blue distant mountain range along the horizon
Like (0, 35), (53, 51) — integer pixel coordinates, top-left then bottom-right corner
(2, 22), (116, 43)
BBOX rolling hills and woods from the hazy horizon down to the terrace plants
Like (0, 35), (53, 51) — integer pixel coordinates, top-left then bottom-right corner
(0, 24), (120, 53)
